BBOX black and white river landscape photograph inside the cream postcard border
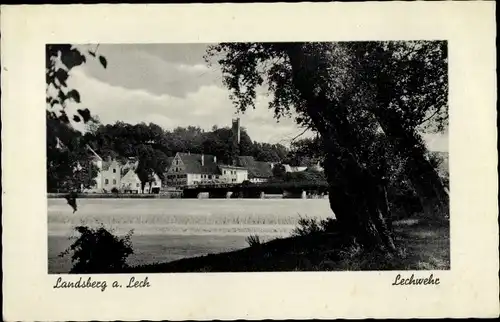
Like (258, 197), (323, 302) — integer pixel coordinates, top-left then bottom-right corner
(46, 40), (453, 274)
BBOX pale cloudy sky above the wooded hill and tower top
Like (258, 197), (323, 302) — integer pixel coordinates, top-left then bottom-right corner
(63, 44), (448, 151)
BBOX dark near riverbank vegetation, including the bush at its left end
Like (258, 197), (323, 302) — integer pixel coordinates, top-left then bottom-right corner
(60, 216), (450, 274)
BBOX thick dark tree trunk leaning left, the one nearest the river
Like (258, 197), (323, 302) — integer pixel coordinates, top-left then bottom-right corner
(284, 44), (396, 252)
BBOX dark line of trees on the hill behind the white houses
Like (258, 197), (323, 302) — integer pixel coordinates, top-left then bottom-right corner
(47, 113), (309, 191)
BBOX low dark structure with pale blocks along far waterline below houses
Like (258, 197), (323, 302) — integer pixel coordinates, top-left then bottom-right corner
(180, 182), (328, 199)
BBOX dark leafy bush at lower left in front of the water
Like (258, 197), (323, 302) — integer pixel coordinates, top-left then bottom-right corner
(59, 225), (134, 274)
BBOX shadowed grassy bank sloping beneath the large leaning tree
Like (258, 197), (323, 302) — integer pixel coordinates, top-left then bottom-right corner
(126, 220), (450, 273)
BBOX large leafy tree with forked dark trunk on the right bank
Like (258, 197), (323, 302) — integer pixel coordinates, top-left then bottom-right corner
(206, 41), (447, 250)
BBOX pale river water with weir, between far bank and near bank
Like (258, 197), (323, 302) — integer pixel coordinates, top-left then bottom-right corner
(48, 199), (332, 273)
